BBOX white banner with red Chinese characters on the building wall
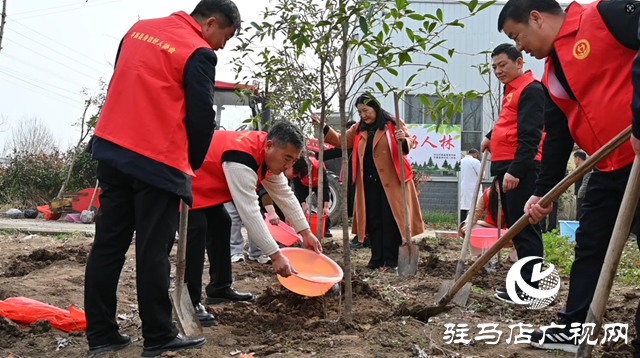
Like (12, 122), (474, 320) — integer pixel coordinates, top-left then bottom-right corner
(407, 124), (461, 172)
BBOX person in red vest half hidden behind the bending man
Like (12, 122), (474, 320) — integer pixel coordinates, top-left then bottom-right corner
(285, 152), (333, 237)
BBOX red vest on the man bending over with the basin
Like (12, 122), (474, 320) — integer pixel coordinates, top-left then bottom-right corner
(192, 130), (267, 209)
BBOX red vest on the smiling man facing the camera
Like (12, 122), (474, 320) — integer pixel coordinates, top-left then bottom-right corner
(491, 71), (544, 162)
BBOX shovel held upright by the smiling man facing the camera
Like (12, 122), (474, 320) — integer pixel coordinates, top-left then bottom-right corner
(436, 149), (489, 306)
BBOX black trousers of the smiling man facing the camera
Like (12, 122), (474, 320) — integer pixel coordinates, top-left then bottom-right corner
(498, 169), (544, 287)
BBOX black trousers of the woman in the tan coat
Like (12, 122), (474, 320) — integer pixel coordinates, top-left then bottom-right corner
(364, 173), (402, 267)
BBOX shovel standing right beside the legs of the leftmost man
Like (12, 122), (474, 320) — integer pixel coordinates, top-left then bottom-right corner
(171, 201), (202, 337)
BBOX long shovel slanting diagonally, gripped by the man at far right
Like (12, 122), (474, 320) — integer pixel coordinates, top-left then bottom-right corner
(421, 126), (631, 320)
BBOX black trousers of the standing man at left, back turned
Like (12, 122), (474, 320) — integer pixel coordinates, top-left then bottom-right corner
(84, 162), (180, 347)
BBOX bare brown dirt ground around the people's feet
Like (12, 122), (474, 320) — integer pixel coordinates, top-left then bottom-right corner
(0, 220), (640, 358)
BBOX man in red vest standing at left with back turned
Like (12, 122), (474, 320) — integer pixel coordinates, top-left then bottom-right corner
(85, 0), (240, 357)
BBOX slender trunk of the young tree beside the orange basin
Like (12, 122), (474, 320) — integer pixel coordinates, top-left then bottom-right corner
(338, 21), (353, 324)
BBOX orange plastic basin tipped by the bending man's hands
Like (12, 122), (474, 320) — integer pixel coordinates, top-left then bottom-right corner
(278, 247), (343, 297)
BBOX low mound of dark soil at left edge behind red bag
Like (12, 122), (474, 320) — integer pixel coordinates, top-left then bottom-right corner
(4, 247), (89, 277)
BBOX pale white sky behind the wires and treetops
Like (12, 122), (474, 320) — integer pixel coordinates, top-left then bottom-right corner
(0, 0), (590, 148)
